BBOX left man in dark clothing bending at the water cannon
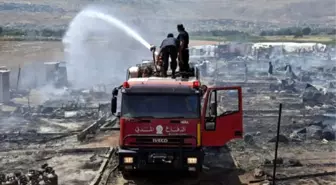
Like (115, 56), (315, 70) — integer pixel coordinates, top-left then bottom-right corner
(160, 33), (177, 78)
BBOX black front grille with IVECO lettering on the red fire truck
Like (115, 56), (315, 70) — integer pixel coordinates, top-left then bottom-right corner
(130, 136), (196, 146)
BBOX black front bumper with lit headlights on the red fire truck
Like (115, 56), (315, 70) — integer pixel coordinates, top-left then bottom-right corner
(118, 149), (204, 172)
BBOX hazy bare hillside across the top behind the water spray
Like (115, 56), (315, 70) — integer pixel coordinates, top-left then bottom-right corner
(0, 0), (336, 30)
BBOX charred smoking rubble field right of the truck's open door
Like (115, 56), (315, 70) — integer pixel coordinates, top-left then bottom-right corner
(189, 43), (336, 184)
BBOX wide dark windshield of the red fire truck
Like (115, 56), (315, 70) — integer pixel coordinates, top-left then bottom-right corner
(121, 94), (200, 119)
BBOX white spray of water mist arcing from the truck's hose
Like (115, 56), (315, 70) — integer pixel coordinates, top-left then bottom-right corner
(63, 7), (151, 88)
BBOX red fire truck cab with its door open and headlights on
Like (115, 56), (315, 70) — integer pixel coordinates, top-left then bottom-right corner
(111, 62), (243, 176)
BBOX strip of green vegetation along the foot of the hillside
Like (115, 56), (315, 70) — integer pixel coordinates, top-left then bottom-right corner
(0, 26), (336, 44)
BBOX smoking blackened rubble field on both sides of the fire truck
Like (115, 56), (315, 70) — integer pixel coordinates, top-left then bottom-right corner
(0, 44), (336, 185)
